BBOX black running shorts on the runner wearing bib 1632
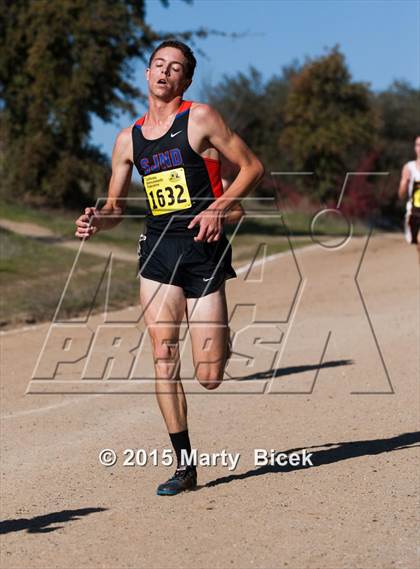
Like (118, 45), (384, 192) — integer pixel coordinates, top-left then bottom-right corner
(138, 230), (236, 298)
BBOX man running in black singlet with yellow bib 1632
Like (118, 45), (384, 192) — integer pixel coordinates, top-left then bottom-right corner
(76, 41), (264, 495)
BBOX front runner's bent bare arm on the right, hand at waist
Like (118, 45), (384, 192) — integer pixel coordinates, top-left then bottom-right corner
(189, 104), (264, 242)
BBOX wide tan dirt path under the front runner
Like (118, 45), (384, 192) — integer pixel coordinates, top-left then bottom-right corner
(1, 231), (420, 569)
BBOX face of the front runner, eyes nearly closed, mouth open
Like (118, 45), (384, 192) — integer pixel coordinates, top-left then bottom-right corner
(146, 47), (191, 100)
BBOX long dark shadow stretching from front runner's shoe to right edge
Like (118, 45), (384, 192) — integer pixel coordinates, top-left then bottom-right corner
(201, 432), (420, 488)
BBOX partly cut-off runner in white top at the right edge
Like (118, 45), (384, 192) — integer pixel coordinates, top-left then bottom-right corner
(398, 136), (420, 263)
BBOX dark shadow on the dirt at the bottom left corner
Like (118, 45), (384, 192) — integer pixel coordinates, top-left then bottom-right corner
(0, 508), (107, 534)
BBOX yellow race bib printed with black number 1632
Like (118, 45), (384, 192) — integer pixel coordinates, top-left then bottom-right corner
(143, 168), (191, 215)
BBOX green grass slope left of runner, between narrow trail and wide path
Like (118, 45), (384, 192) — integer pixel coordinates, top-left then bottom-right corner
(0, 230), (138, 328)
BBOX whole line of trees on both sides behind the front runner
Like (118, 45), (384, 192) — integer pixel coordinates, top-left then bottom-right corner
(0, 0), (420, 222)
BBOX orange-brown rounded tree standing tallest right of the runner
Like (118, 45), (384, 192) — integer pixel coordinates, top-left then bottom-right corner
(280, 47), (377, 201)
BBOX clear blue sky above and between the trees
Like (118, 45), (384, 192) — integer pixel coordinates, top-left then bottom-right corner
(92, 0), (420, 160)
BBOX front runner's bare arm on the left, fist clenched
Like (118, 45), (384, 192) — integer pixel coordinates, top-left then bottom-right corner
(75, 127), (133, 239)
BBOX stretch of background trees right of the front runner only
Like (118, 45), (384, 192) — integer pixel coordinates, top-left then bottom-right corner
(203, 46), (420, 222)
